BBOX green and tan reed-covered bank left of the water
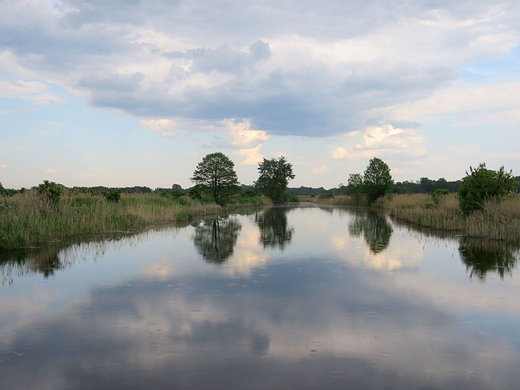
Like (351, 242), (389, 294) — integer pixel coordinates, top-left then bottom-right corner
(0, 190), (264, 249)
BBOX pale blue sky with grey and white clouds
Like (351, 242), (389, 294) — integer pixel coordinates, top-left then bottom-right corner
(0, 0), (520, 189)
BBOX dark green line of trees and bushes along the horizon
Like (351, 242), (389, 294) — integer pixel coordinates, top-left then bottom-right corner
(0, 152), (520, 210)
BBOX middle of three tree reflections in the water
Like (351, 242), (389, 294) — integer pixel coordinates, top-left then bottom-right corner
(255, 207), (294, 250)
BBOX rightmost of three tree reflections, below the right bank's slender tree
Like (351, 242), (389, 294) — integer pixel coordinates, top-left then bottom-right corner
(348, 211), (393, 253)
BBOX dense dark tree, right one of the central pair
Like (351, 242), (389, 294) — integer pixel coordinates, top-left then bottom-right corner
(255, 156), (295, 203)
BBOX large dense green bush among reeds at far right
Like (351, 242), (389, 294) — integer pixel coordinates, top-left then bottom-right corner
(459, 163), (516, 214)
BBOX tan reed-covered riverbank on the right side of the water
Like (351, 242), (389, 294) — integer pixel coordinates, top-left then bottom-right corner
(302, 194), (520, 244)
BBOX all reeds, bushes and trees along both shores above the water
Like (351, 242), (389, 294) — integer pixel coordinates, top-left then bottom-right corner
(0, 153), (520, 250)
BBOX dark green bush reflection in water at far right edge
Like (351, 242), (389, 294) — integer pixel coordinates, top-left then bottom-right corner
(459, 237), (519, 281)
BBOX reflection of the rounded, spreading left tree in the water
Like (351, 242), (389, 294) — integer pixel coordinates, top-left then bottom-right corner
(193, 218), (242, 263)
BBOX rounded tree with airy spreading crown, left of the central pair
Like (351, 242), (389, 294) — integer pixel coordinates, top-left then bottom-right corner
(190, 152), (240, 205)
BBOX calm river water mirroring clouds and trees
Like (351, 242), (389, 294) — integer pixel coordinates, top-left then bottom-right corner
(0, 207), (520, 390)
